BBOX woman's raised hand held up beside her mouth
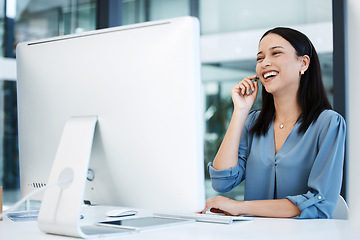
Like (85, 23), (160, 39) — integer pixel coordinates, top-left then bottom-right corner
(231, 75), (259, 111)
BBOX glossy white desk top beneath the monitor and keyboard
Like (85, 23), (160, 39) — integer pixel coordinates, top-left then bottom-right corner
(0, 205), (360, 240)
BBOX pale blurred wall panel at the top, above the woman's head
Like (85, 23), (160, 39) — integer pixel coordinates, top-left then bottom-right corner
(200, 0), (337, 34)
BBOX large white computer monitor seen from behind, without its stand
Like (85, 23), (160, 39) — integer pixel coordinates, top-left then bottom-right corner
(17, 17), (205, 211)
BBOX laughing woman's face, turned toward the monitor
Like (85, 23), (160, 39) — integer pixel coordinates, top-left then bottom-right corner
(256, 33), (306, 96)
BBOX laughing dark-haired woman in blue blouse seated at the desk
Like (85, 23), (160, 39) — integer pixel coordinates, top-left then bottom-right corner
(203, 28), (346, 218)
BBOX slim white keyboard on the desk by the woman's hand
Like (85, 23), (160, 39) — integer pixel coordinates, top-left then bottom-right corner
(154, 212), (253, 224)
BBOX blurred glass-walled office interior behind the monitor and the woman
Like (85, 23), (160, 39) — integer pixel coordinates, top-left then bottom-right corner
(0, 0), (345, 208)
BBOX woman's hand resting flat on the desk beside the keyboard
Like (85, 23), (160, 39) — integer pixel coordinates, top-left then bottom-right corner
(200, 196), (242, 216)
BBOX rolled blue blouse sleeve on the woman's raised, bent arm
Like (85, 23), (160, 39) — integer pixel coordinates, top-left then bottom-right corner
(208, 111), (257, 192)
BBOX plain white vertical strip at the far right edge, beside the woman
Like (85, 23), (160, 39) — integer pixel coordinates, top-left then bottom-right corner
(346, 0), (360, 228)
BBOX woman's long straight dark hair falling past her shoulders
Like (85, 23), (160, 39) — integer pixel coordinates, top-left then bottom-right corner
(250, 27), (332, 136)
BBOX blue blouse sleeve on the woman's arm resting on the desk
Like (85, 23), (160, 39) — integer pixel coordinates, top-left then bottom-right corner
(286, 111), (346, 218)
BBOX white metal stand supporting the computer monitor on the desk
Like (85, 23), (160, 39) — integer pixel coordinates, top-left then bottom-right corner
(38, 116), (136, 238)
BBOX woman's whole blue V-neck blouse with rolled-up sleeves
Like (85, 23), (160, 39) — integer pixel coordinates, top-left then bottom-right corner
(208, 110), (346, 218)
